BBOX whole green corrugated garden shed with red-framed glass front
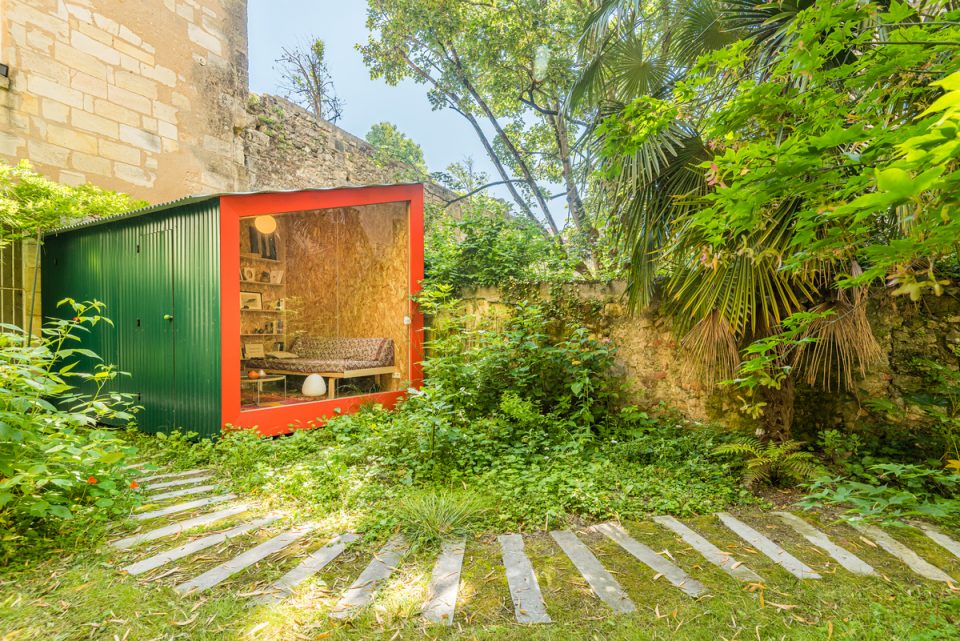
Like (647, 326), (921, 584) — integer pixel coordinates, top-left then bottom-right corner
(41, 184), (423, 436)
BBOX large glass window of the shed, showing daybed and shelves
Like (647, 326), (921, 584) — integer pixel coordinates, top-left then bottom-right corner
(238, 202), (410, 409)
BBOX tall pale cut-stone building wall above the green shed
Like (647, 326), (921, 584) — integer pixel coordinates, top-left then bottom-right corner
(0, 0), (247, 202)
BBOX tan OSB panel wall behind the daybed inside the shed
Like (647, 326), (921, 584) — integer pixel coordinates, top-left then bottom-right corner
(279, 203), (410, 390)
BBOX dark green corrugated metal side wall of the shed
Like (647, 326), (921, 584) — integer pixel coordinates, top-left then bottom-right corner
(41, 198), (220, 436)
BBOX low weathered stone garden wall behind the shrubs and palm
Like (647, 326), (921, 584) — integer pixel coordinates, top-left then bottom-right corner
(463, 281), (960, 434)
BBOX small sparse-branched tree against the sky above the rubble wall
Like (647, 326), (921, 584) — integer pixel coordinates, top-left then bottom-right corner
(276, 38), (343, 122)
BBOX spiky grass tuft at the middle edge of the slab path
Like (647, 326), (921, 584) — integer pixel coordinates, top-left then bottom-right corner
(394, 488), (489, 545)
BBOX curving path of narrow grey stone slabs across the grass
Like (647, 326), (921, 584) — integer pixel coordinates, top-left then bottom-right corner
(110, 463), (960, 626)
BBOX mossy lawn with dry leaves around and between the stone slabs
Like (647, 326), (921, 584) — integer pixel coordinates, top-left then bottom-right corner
(0, 498), (960, 641)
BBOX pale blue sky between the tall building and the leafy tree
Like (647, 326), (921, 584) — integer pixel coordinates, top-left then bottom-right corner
(248, 0), (495, 185)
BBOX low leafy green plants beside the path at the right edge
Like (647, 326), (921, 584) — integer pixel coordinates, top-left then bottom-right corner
(800, 463), (960, 525)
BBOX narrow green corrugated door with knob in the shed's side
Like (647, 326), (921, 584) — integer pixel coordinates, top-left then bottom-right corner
(134, 229), (177, 432)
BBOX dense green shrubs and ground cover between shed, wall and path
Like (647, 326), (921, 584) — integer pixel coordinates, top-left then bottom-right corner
(144, 304), (754, 528)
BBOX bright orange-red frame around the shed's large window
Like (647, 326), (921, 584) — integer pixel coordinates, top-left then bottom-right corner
(220, 185), (423, 436)
